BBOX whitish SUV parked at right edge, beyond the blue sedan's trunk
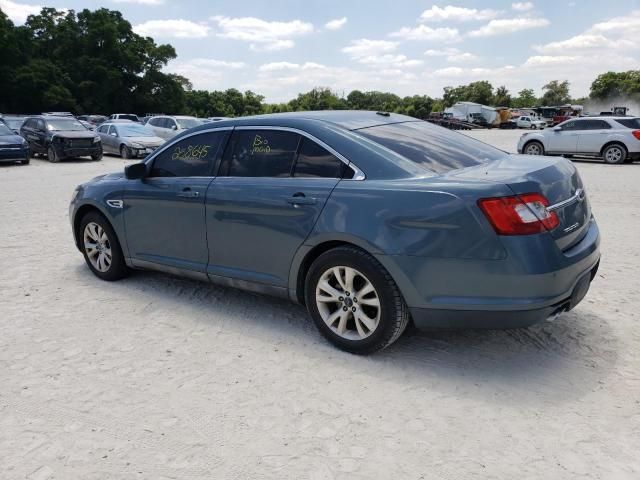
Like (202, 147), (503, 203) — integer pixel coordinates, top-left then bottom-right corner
(518, 117), (640, 163)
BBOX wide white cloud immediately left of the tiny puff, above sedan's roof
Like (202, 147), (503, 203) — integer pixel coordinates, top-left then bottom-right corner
(212, 16), (313, 51)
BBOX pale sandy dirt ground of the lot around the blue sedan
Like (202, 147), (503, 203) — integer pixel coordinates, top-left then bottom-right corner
(0, 131), (640, 480)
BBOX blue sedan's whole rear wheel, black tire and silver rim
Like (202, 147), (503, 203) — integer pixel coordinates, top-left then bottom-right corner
(305, 246), (410, 355)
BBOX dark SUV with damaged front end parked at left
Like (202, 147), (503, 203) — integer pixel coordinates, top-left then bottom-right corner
(20, 115), (102, 162)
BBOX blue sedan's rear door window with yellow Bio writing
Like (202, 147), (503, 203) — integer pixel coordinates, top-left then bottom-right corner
(221, 129), (300, 177)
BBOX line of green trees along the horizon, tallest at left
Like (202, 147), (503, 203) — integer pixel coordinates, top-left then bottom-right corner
(0, 8), (640, 118)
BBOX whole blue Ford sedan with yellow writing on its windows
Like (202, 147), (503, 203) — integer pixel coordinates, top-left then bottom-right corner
(70, 111), (600, 353)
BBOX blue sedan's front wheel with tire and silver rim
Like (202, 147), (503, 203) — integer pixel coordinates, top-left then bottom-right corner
(77, 212), (129, 282)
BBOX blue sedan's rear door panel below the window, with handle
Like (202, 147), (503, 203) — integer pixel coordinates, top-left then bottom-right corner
(206, 177), (338, 287)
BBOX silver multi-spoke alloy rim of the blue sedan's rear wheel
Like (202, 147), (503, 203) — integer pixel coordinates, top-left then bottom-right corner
(316, 266), (382, 340)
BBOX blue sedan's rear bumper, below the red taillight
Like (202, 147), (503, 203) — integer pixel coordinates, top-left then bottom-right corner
(376, 220), (600, 329)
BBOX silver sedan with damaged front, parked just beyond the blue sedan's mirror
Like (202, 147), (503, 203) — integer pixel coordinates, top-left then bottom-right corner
(96, 120), (164, 158)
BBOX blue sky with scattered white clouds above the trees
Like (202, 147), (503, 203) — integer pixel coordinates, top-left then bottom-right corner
(0, 0), (640, 102)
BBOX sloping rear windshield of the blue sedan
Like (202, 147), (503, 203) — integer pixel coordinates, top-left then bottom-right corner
(356, 121), (507, 173)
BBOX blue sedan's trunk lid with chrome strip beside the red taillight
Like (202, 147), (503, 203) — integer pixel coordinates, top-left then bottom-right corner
(454, 155), (591, 250)
